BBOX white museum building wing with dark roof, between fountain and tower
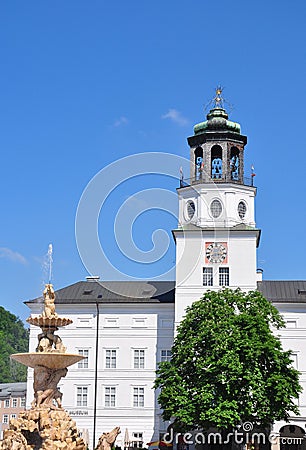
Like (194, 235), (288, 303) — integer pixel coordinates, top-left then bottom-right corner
(27, 277), (174, 448)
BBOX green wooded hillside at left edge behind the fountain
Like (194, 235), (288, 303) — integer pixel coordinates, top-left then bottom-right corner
(0, 306), (29, 383)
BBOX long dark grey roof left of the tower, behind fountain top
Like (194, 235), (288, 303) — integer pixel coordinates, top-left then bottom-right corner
(25, 280), (175, 304)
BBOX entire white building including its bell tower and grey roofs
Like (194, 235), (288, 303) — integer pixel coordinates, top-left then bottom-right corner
(27, 105), (306, 450)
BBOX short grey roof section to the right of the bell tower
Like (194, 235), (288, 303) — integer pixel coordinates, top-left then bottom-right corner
(257, 280), (306, 303)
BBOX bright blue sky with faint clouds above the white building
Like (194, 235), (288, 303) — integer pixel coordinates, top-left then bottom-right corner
(0, 0), (306, 318)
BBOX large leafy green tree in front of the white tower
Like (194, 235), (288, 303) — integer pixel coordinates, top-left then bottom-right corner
(155, 289), (301, 431)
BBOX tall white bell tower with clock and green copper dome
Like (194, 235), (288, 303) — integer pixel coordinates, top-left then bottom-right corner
(173, 88), (260, 323)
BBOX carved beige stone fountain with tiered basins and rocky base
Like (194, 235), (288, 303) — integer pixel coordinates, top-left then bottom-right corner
(0, 284), (120, 450)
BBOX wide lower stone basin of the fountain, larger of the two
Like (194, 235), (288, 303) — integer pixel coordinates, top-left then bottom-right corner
(11, 352), (84, 369)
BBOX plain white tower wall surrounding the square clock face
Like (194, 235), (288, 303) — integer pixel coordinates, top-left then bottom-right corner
(175, 229), (257, 324)
